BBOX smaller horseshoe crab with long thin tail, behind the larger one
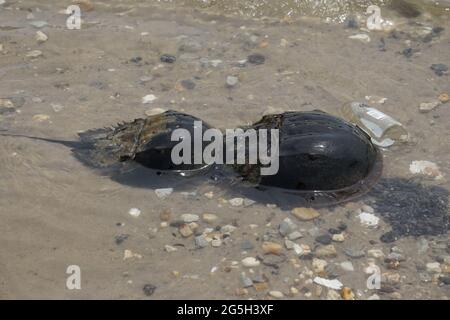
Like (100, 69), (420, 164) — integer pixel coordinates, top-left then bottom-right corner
(74, 111), (210, 171)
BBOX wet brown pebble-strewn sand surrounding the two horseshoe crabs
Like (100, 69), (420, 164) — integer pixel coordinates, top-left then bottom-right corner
(0, 1), (450, 299)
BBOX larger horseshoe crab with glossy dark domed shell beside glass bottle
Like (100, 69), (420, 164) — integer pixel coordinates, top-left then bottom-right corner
(235, 111), (382, 202)
